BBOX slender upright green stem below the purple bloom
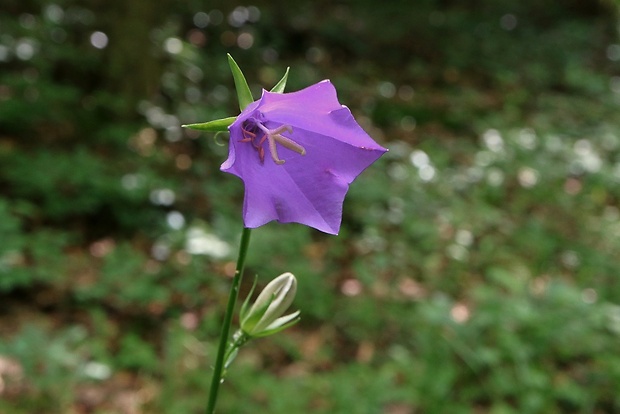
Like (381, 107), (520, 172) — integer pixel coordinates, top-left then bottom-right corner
(206, 227), (251, 414)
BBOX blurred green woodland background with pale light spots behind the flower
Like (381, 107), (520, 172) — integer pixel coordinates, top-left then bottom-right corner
(0, 0), (620, 414)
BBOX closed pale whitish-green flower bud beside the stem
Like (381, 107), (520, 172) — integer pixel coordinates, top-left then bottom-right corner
(241, 272), (299, 338)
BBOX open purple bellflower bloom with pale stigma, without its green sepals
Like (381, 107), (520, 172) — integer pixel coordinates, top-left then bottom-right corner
(221, 80), (387, 234)
